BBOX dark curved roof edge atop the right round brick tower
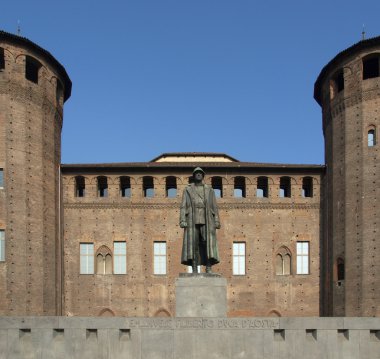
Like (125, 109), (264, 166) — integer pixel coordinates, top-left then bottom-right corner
(314, 36), (380, 106)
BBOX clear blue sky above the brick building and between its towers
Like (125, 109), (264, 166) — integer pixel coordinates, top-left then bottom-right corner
(0, 0), (380, 164)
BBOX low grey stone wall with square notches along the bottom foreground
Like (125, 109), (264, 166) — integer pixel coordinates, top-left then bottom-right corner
(0, 317), (380, 359)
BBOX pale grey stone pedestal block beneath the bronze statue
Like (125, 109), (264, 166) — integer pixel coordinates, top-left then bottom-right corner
(175, 273), (227, 318)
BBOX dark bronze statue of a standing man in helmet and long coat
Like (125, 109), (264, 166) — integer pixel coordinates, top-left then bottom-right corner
(179, 167), (220, 273)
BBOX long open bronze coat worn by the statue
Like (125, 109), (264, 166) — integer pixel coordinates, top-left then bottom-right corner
(180, 183), (220, 265)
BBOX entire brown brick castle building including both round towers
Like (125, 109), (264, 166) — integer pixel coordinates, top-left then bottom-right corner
(0, 32), (380, 316)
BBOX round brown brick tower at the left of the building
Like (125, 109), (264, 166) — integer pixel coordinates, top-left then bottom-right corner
(0, 31), (71, 315)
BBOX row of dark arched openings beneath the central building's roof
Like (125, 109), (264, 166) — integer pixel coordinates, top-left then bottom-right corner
(75, 176), (313, 198)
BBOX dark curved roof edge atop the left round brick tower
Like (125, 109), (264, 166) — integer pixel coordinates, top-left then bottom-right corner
(0, 30), (72, 101)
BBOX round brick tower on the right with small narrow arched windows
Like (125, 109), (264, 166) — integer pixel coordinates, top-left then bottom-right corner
(314, 37), (380, 316)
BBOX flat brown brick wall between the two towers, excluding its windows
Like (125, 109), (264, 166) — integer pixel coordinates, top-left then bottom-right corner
(63, 170), (321, 316)
